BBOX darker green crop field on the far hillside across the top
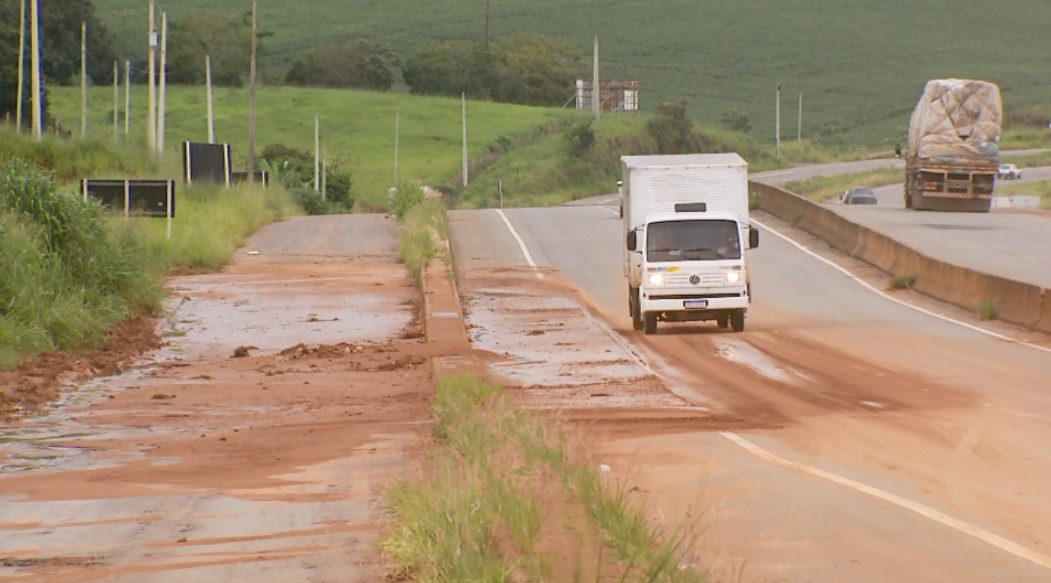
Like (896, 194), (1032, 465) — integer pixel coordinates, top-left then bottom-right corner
(95, 0), (1051, 147)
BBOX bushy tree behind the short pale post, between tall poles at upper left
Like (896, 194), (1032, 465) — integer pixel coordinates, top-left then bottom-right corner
(168, 11), (252, 87)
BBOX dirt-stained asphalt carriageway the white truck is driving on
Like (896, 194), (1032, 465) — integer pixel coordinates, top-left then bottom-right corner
(452, 204), (1051, 581)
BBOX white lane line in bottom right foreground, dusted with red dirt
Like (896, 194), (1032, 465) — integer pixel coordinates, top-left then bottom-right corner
(719, 432), (1051, 568)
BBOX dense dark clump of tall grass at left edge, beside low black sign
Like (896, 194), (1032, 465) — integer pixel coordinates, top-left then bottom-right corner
(0, 161), (163, 367)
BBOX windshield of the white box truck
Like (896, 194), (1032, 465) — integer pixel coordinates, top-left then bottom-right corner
(646, 221), (741, 263)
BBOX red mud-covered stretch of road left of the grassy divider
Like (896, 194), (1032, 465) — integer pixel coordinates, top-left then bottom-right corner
(0, 217), (469, 582)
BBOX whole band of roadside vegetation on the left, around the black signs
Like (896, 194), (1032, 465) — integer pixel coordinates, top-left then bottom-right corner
(0, 130), (300, 369)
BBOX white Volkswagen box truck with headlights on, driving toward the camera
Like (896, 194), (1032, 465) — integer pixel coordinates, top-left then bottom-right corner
(620, 153), (759, 334)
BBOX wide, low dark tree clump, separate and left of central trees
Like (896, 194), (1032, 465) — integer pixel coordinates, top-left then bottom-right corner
(285, 40), (400, 90)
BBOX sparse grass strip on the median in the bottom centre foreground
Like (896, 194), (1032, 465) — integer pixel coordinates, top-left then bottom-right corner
(382, 375), (704, 582)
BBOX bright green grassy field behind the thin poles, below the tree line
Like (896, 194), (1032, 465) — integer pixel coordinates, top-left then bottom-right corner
(50, 86), (575, 204)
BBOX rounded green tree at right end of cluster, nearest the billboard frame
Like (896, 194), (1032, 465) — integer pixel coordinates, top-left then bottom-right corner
(491, 33), (582, 105)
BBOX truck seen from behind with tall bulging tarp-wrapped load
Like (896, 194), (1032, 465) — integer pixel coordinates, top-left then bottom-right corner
(905, 79), (1004, 212)
